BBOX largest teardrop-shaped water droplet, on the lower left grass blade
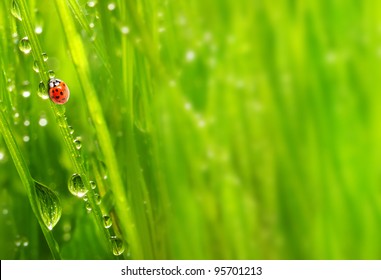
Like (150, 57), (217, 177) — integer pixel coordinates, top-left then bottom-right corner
(34, 182), (62, 230)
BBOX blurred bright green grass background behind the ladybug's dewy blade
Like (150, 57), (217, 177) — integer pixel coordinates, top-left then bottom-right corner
(0, 0), (381, 259)
